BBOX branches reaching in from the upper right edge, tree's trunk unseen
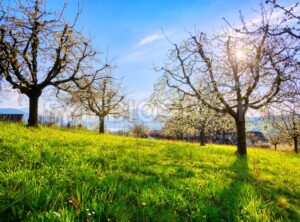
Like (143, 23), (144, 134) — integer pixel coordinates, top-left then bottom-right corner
(262, 0), (300, 102)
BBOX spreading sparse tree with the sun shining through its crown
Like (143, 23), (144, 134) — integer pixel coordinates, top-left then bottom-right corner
(160, 26), (289, 154)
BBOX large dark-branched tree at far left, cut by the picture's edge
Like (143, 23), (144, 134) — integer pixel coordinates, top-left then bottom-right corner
(0, 0), (105, 126)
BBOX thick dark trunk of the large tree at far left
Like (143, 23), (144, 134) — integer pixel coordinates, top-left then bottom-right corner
(27, 92), (41, 127)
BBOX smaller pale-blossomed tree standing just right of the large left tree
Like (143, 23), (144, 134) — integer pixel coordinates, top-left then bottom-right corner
(64, 74), (127, 133)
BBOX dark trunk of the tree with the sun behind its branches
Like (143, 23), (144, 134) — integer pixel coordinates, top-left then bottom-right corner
(235, 116), (247, 155)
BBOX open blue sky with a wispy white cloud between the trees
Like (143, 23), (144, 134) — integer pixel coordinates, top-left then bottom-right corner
(0, 0), (288, 108)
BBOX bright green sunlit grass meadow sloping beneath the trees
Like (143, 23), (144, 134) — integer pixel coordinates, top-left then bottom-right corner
(0, 123), (300, 221)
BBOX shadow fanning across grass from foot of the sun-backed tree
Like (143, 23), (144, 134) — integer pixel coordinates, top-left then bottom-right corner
(219, 156), (299, 221)
